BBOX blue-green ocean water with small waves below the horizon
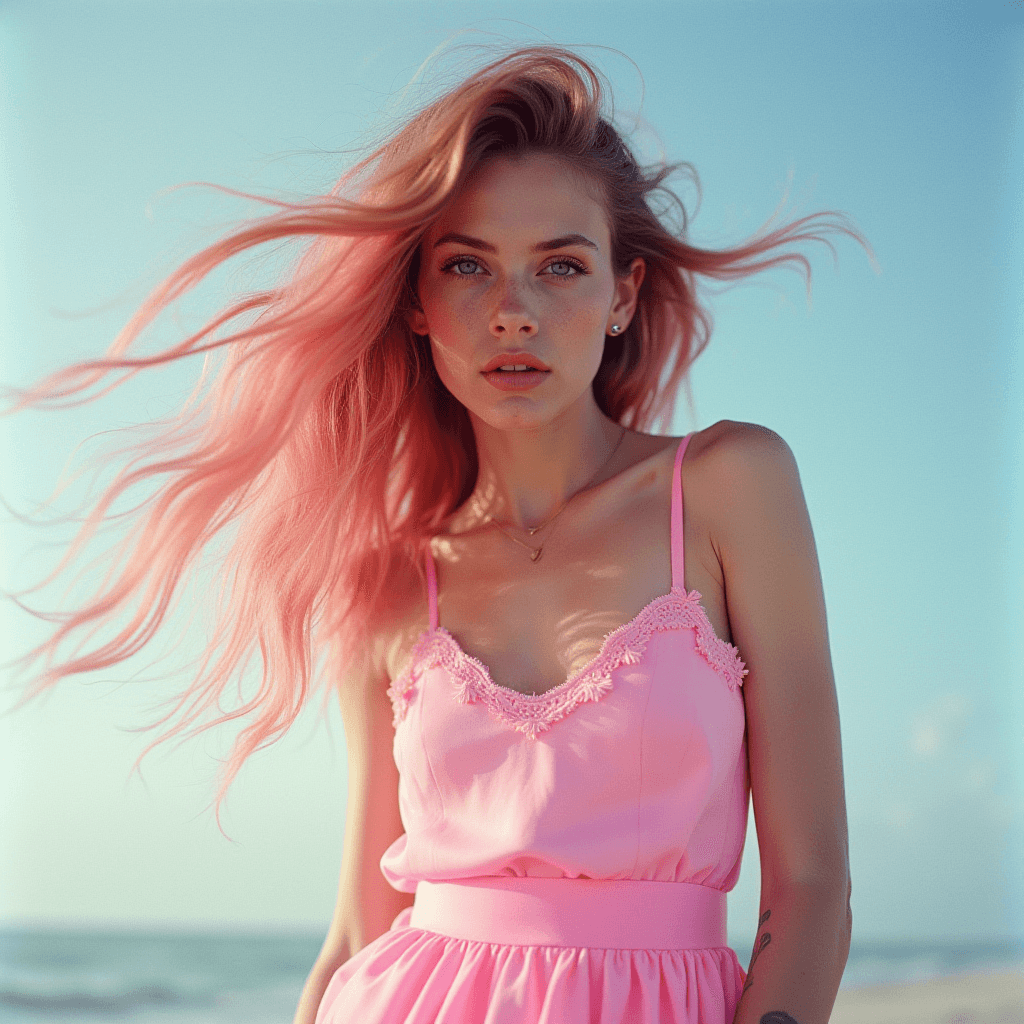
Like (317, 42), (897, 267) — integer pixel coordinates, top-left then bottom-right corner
(0, 929), (1024, 1024)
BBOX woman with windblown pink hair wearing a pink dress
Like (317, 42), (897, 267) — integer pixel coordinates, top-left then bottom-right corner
(8, 46), (872, 1024)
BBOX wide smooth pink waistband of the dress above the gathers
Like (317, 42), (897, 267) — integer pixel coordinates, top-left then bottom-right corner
(403, 876), (727, 949)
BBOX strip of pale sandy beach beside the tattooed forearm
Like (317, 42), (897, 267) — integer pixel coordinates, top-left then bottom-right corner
(829, 965), (1024, 1024)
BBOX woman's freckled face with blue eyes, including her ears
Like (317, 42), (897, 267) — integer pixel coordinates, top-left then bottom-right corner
(409, 154), (644, 429)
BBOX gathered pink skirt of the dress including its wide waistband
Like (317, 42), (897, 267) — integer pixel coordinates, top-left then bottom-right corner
(316, 877), (746, 1024)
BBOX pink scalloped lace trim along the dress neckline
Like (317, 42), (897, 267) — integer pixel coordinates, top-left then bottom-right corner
(387, 587), (748, 739)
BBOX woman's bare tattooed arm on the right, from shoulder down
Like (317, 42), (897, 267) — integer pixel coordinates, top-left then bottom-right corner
(707, 423), (853, 1024)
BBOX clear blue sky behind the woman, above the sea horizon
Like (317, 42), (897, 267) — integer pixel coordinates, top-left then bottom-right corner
(0, 0), (1024, 945)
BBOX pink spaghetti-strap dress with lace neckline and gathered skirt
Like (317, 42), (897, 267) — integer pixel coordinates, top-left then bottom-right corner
(316, 434), (750, 1024)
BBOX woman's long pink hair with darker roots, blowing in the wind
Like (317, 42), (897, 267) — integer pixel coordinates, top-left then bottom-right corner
(4, 46), (870, 826)
